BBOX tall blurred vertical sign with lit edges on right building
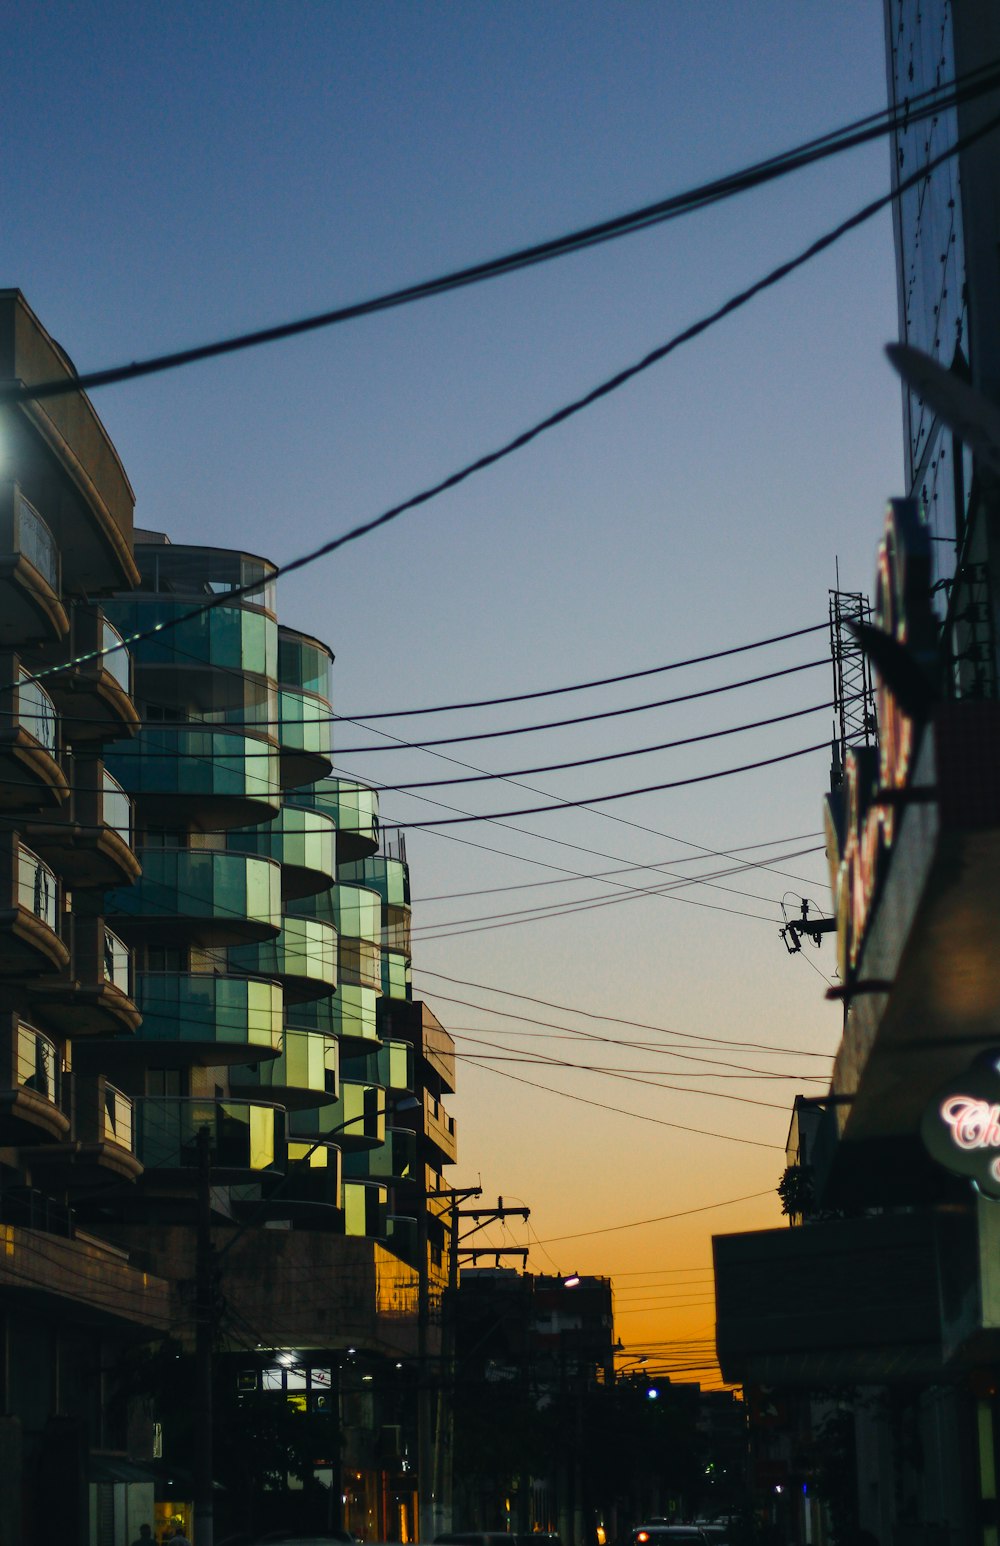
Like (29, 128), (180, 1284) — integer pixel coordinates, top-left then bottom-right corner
(832, 499), (937, 982)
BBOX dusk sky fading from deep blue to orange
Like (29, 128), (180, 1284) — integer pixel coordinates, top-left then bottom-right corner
(0, 0), (904, 1382)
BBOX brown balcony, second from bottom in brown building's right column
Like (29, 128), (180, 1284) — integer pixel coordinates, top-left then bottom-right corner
(28, 912), (141, 1037)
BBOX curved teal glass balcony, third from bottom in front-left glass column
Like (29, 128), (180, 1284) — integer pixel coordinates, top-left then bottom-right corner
(107, 849), (281, 946)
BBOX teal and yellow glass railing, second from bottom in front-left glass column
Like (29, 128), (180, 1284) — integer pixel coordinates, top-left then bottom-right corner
(136, 971), (283, 1051)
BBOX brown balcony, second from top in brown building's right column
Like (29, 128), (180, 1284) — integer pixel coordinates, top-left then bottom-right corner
(22, 758), (139, 890)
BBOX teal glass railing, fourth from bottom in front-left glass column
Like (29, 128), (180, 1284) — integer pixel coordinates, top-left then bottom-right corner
(107, 725), (280, 815)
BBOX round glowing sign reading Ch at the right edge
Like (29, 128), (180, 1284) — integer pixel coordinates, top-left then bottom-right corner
(920, 1048), (1000, 1200)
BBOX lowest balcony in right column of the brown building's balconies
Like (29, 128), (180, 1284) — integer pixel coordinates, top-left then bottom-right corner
(31, 1073), (142, 1189)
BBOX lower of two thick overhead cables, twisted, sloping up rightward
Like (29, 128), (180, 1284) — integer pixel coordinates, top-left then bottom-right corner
(13, 93), (1000, 691)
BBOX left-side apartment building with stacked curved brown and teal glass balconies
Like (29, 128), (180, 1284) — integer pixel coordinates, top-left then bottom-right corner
(0, 292), (456, 1546)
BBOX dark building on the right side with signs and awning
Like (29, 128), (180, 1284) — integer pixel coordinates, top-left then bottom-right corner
(716, 12), (1000, 1546)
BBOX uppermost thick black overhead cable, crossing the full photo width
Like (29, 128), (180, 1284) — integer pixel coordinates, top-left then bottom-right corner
(0, 63), (1000, 404)
